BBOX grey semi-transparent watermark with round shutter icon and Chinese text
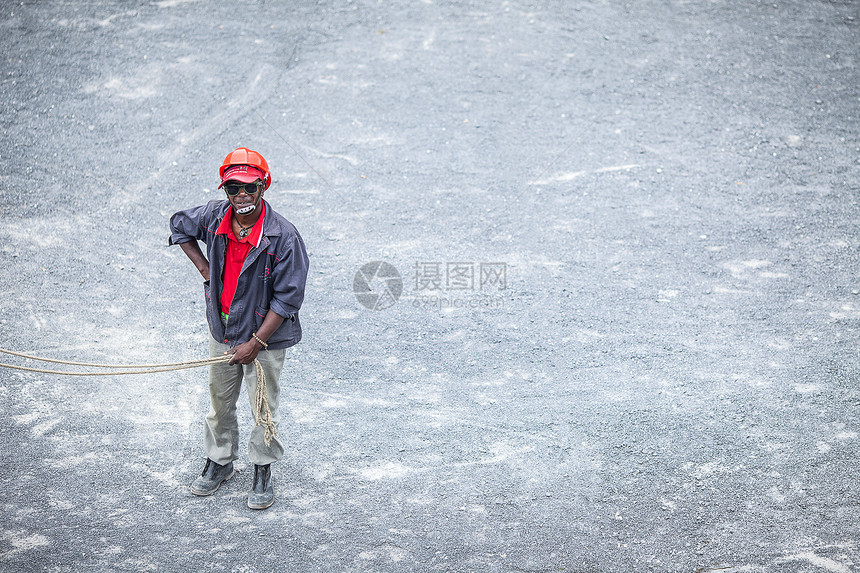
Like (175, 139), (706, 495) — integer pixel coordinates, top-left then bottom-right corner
(353, 261), (508, 311)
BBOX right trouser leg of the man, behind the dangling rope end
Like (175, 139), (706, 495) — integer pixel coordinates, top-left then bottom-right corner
(245, 348), (287, 465)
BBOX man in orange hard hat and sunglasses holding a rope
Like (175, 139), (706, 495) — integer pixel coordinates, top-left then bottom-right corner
(170, 147), (308, 509)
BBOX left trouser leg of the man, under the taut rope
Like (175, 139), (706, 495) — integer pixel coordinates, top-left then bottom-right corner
(203, 337), (242, 465)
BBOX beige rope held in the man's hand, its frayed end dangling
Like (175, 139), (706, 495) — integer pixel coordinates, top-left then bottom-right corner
(0, 348), (278, 446)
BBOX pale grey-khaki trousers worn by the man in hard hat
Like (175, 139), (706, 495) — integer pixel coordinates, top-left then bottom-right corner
(203, 336), (287, 465)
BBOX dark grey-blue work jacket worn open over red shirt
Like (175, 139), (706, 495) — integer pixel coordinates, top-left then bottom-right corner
(169, 200), (308, 350)
